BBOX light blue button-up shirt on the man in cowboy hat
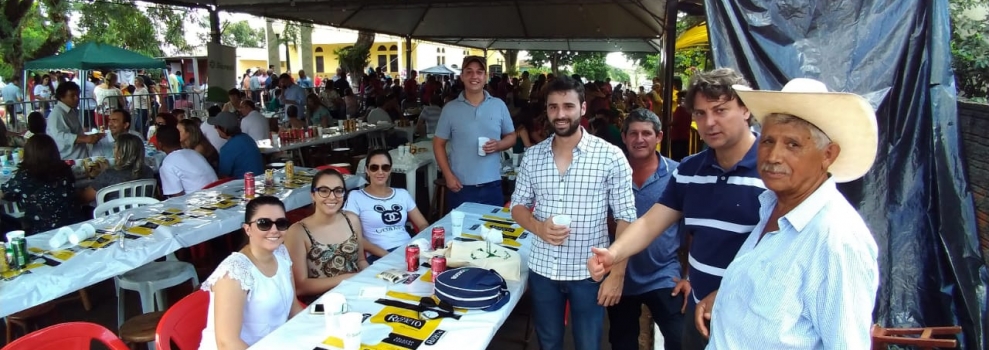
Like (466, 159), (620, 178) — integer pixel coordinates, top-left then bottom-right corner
(707, 179), (879, 350)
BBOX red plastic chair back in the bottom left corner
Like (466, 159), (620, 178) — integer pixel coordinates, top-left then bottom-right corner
(3, 322), (129, 350)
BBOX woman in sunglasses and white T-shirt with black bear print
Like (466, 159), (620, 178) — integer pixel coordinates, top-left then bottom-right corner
(343, 149), (429, 263)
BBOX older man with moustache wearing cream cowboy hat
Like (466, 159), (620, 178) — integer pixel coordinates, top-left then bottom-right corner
(694, 78), (879, 350)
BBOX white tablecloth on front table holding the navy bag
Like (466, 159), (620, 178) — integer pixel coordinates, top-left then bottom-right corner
(250, 203), (532, 350)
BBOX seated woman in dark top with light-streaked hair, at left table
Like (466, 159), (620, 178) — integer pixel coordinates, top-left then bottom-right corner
(82, 133), (155, 203)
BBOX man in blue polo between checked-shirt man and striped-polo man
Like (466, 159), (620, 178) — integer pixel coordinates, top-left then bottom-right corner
(599, 108), (690, 350)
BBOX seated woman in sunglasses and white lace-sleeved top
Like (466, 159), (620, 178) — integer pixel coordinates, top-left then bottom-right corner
(199, 196), (302, 350)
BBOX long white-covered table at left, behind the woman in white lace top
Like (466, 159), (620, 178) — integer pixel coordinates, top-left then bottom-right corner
(0, 168), (365, 317)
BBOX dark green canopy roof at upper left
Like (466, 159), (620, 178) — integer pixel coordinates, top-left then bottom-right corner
(24, 43), (165, 70)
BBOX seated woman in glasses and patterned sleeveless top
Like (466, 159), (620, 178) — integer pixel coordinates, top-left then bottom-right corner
(285, 169), (368, 302)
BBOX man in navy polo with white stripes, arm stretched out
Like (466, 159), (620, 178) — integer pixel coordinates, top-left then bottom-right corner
(587, 68), (765, 349)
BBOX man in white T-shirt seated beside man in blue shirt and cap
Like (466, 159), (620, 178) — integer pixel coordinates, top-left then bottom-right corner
(155, 125), (216, 197)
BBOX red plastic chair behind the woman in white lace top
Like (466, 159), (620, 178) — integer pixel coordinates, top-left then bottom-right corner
(155, 290), (209, 350)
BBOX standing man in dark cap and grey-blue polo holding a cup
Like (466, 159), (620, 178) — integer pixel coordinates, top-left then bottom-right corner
(438, 56), (515, 209)
